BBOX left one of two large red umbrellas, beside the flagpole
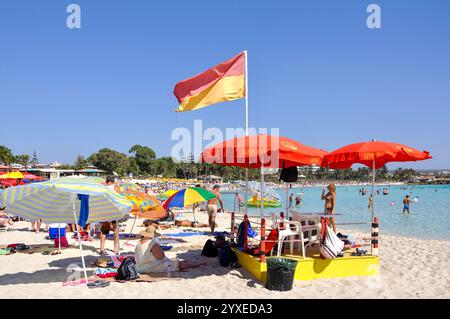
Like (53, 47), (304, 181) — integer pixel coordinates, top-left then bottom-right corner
(200, 134), (327, 216)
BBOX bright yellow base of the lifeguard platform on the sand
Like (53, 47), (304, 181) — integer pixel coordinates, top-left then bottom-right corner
(234, 249), (380, 283)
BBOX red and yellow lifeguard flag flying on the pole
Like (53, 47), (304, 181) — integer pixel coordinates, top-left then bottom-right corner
(173, 52), (246, 112)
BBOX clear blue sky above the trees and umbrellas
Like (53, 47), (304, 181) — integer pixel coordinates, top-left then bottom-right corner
(0, 0), (450, 168)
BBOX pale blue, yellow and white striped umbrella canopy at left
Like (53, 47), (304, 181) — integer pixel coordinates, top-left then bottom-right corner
(2, 177), (132, 223)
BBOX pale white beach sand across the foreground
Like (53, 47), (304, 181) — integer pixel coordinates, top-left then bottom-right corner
(0, 213), (450, 299)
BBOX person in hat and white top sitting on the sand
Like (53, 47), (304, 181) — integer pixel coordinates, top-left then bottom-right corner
(135, 226), (206, 274)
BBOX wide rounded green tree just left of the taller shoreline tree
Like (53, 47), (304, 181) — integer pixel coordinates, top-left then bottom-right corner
(87, 148), (130, 176)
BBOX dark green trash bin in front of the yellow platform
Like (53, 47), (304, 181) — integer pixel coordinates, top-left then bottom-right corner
(266, 257), (297, 291)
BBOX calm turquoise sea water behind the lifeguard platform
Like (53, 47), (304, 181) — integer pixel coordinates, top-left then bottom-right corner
(222, 185), (450, 241)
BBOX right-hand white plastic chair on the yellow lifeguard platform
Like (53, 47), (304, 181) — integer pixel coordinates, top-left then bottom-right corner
(292, 212), (321, 258)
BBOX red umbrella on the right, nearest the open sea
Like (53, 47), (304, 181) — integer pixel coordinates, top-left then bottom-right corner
(322, 140), (432, 248)
